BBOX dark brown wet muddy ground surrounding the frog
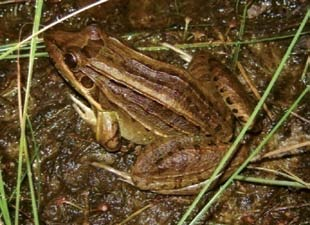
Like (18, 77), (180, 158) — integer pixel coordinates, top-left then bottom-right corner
(0, 0), (310, 225)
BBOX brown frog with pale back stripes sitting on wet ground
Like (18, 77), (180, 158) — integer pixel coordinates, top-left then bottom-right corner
(45, 26), (252, 194)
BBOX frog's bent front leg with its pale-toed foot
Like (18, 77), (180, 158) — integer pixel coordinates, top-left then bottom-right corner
(70, 95), (121, 151)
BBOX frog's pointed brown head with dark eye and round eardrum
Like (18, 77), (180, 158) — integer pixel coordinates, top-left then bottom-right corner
(44, 26), (106, 109)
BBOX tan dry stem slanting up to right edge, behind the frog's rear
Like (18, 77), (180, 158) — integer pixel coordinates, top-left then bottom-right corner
(251, 141), (310, 162)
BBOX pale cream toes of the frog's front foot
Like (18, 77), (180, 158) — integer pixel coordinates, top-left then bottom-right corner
(70, 95), (97, 127)
